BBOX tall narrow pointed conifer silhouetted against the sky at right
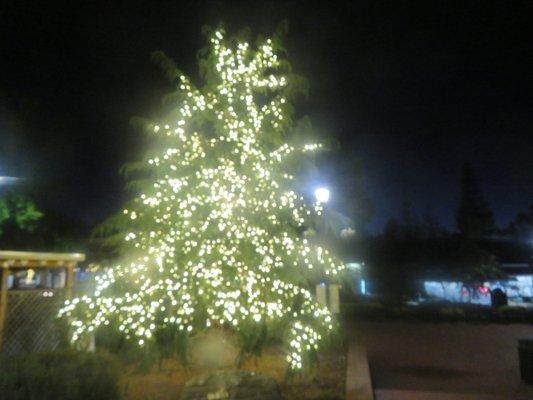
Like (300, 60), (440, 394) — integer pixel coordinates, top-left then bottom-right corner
(456, 164), (495, 240)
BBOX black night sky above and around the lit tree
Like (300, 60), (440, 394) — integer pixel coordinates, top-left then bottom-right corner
(0, 1), (533, 231)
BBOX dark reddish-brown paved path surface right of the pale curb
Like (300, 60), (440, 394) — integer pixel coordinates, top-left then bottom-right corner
(352, 322), (533, 400)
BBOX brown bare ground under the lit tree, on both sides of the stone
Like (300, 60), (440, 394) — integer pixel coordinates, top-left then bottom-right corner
(120, 347), (346, 400)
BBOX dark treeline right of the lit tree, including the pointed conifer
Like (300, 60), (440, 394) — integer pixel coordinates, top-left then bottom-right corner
(347, 165), (533, 300)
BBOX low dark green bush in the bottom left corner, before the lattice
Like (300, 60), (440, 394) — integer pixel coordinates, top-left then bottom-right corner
(0, 351), (120, 400)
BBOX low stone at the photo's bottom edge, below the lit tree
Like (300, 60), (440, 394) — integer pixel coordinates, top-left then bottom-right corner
(180, 370), (282, 400)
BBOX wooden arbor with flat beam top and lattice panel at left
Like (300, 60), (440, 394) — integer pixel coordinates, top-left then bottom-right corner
(0, 251), (85, 351)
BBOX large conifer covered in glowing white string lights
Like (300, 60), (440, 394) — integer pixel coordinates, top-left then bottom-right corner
(60, 26), (343, 369)
